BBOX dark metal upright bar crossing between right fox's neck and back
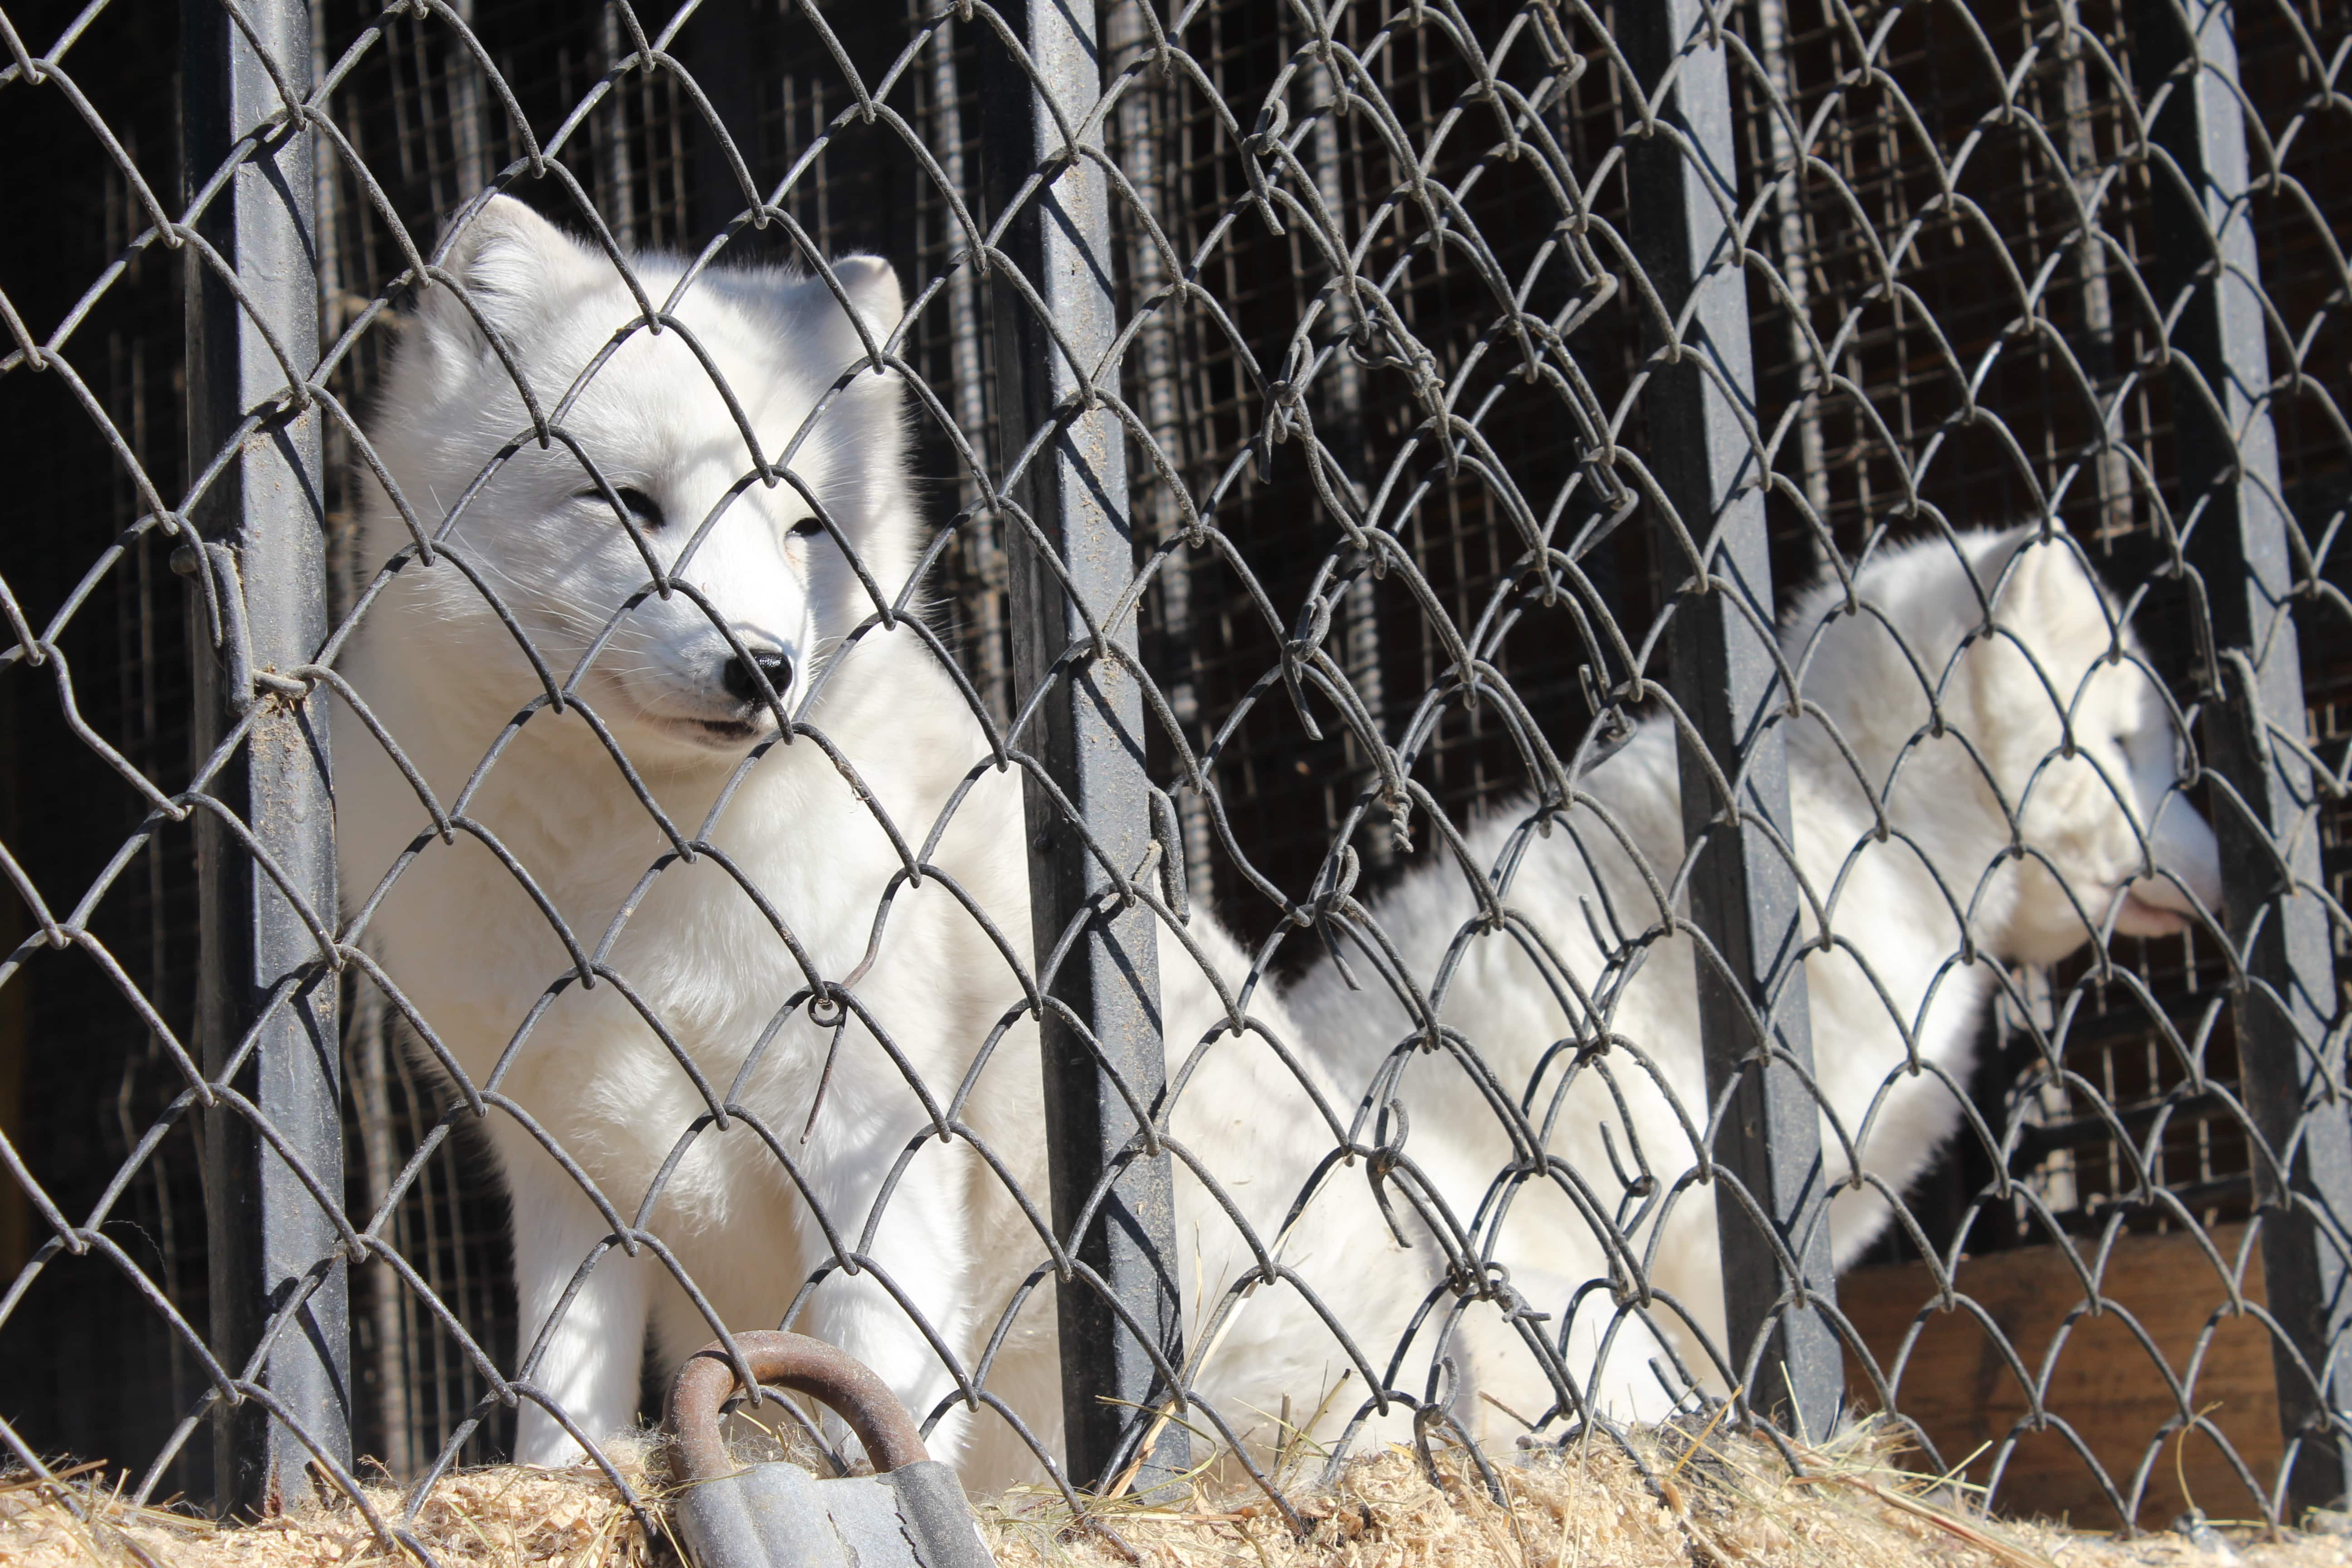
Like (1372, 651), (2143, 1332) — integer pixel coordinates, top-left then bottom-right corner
(1625, 0), (1844, 1434)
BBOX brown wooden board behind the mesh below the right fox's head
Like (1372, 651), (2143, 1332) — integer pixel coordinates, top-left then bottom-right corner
(1837, 1225), (2284, 1528)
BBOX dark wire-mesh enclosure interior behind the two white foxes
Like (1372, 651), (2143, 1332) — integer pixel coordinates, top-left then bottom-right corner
(0, 0), (2352, 1514)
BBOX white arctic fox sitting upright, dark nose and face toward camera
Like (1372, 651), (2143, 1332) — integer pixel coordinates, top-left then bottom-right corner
(336, 197), (1442, 1483)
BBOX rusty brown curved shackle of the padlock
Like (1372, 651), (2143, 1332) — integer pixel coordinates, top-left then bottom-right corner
(663, 1328), (931, 1481)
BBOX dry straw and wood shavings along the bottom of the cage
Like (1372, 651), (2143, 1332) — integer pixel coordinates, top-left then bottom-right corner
(0, 1425), (2352, 1568)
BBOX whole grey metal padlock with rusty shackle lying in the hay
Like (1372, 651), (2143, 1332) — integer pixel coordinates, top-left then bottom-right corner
(666, 1331), (995, 1568)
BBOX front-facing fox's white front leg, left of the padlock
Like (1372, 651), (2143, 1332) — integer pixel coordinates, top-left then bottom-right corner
(506, 1145), (659, 1465)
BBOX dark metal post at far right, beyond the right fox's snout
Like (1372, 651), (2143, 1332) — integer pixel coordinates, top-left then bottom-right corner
(2133, 0), (2352, 1516)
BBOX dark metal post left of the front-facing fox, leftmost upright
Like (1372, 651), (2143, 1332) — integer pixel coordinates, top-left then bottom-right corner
(174, 0), (350, 1514)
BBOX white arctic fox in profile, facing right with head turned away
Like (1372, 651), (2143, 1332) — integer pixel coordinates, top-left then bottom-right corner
(1287, 529), (2220, 1427)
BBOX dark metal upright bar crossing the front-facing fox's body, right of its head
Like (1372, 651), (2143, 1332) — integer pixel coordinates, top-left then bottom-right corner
(981, 0), (1186, 1490)
